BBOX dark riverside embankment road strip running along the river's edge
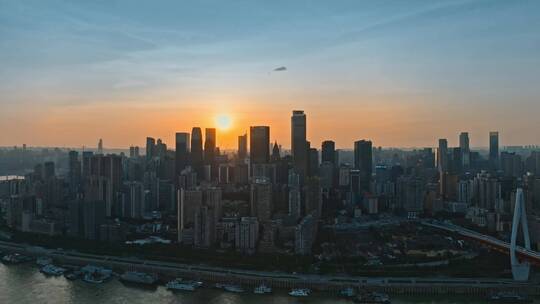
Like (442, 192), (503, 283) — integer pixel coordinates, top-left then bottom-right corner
(0, 241), (540, 296)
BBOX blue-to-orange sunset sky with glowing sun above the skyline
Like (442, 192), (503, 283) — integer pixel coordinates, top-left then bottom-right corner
(0, 0), (540, 148)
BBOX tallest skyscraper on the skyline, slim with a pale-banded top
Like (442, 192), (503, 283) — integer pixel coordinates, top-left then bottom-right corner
(291, 110), (308, 181)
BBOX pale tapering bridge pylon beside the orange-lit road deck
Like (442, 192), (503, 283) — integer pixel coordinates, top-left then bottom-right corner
(510, 188), (531, 281)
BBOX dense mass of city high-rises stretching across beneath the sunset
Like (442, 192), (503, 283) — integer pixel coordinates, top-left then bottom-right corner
(0, 110), (540, 255)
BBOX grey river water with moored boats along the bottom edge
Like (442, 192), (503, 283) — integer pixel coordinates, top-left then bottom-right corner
(0, 264), (540, 304)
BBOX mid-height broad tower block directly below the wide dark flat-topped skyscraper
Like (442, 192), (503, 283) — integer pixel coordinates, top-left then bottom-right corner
(250, 177), (273, 222)
